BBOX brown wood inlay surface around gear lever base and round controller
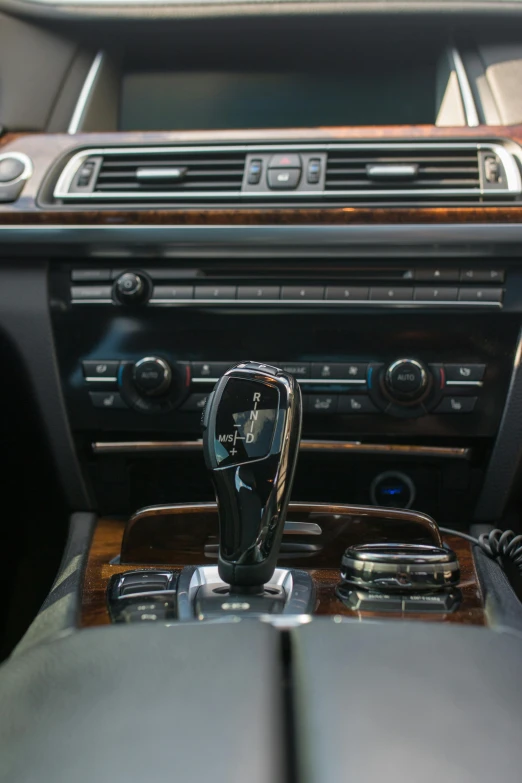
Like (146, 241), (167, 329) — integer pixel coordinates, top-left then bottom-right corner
(81, 514), (485, 626)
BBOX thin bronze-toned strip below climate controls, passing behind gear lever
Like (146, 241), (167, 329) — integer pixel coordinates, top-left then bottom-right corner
(92, 438), (472, 459)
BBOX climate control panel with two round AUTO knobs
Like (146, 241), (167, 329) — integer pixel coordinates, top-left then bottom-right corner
(82, 355), (487, 419)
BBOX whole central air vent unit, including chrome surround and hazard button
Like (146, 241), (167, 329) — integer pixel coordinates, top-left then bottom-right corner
(54, 141), (522, 207)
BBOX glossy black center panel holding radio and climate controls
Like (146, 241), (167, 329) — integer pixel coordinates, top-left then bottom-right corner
(50, 254), (522, 526)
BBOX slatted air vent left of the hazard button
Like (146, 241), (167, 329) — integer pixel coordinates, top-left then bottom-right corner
(55, 147), (246, 201)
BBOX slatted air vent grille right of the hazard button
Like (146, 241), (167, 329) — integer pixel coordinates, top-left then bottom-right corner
(325, 150), (480, 195)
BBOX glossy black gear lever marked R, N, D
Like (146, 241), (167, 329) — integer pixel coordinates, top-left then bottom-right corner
(202, 362), (302, 592)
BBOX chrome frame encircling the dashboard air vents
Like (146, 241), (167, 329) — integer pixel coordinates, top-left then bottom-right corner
(53, 141), (522, 204)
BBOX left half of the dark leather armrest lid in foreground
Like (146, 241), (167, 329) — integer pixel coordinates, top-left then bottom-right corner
(0, 623), (284, 783)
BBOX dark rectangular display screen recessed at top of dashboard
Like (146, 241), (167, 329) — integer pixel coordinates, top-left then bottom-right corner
(120, 71), (435, 131)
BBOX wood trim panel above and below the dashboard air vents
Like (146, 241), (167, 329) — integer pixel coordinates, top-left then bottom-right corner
(0, 125), (522, 226)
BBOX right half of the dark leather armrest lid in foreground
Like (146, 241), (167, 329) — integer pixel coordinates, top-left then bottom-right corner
(292, 620), (522, 783)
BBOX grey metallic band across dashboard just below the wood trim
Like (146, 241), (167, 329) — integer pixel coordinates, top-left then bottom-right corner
(0, 223), (522, 245)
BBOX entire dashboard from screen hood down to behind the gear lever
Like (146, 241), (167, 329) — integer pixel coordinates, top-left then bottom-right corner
(0, 3), (522, 608)
